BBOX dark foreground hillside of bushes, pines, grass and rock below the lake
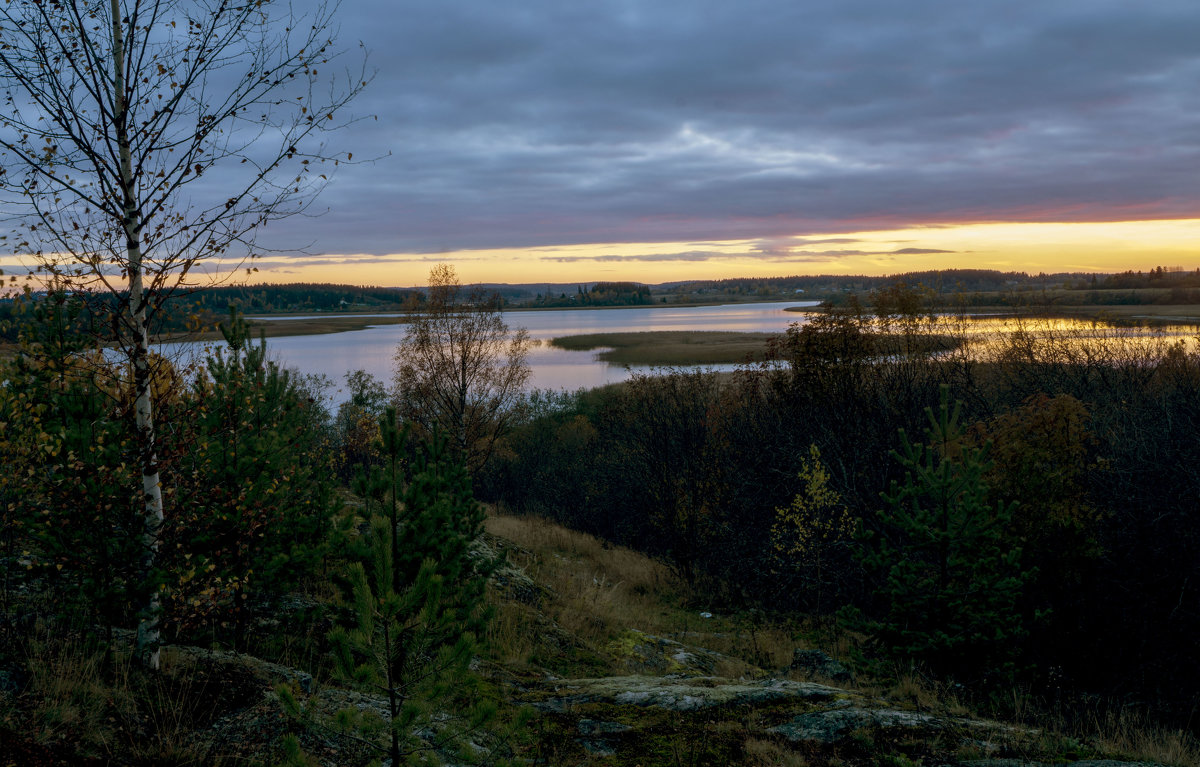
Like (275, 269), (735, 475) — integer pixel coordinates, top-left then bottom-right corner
(0, 288), (1200, 767)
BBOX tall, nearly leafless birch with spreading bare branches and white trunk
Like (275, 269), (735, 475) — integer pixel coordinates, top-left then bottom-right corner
(0, 0), (366, 667)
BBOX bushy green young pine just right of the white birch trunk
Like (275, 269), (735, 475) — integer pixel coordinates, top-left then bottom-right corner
(161, 307), (337, 647)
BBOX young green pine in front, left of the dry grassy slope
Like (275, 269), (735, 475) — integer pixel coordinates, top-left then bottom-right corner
(330, 408), (499, 767)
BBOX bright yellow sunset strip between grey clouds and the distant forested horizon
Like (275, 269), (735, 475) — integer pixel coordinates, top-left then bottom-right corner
(238, 218), (1200, 286)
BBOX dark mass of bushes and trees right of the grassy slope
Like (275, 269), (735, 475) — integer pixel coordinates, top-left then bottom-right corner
(479, 304), (1200, 724)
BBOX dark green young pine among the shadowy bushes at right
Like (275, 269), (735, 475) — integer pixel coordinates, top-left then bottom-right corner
(844, 387), (1031, 679)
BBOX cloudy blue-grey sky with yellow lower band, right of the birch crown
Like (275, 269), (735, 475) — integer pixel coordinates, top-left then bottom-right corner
(243, 0), (1200, 284)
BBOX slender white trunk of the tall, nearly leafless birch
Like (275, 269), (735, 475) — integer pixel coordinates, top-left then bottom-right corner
(109, 0), (163, 669)
